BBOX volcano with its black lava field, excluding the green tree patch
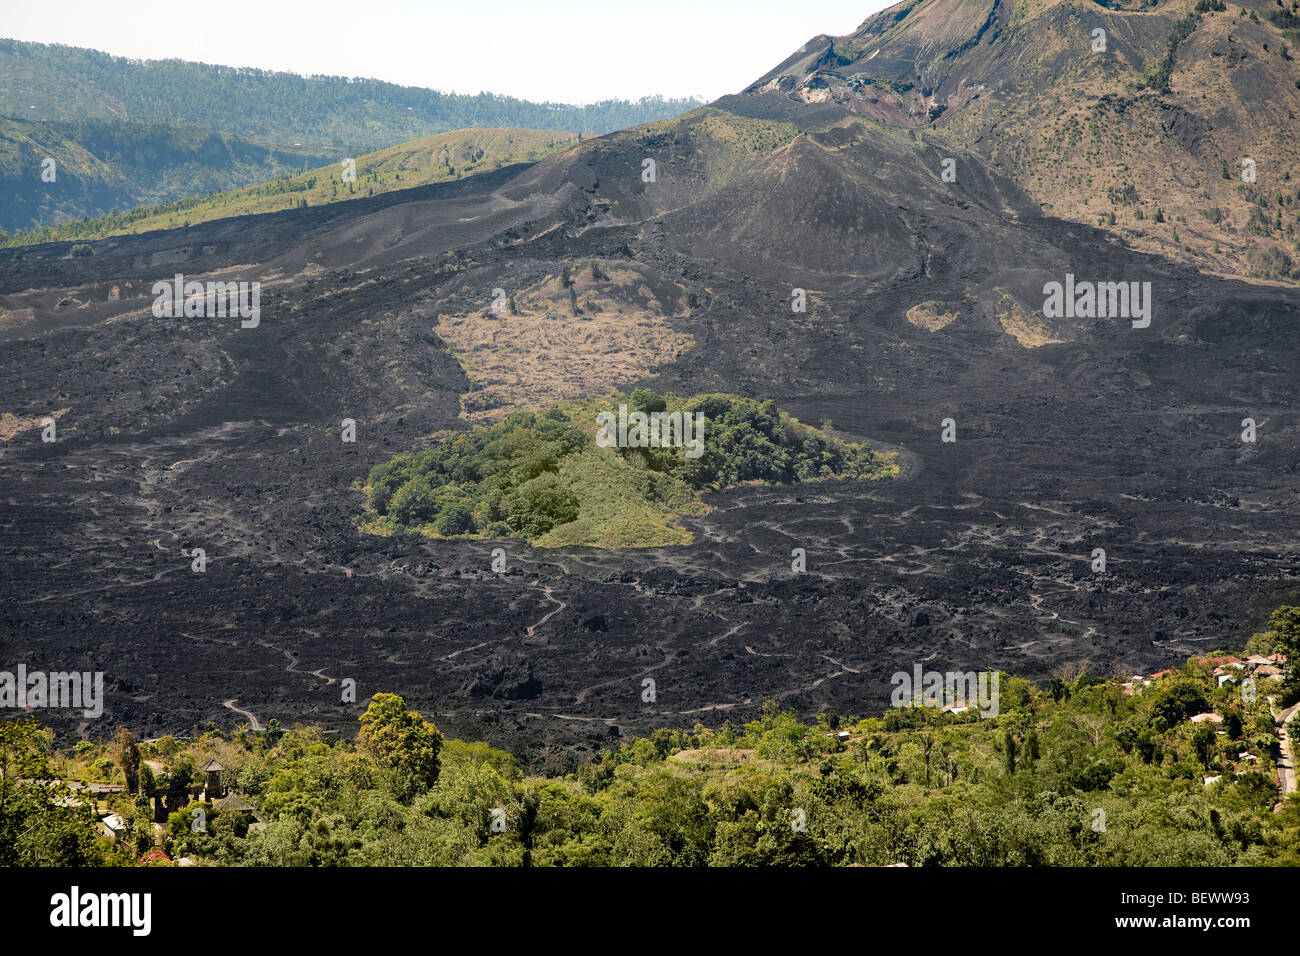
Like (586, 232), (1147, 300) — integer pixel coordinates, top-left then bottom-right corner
(0, 0), (1300, 765)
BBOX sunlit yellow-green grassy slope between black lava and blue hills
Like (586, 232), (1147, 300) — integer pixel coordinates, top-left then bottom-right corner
(0, 127), (579, 246)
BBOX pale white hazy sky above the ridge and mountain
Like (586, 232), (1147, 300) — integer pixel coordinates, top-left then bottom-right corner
(0, 0), (889, 103)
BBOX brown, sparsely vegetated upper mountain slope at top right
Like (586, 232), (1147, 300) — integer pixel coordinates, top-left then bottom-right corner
(724, 0), (1300, 280)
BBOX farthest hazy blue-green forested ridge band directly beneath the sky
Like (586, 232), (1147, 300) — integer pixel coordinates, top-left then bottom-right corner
(0, 39), (699, 151)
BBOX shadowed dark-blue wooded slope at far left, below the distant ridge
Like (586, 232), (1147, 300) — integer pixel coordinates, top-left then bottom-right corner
(0, 117), (334, 233)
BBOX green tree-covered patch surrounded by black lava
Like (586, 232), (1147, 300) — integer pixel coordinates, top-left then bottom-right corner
(360, 389), (898, 548)
